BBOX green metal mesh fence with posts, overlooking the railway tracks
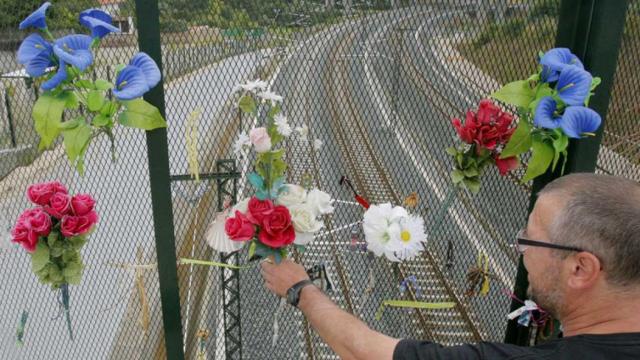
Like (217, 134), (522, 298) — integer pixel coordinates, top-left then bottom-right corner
(0, 0), (640, 359)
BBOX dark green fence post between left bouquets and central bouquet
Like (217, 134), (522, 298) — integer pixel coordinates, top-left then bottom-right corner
(136, 0), (184, 360)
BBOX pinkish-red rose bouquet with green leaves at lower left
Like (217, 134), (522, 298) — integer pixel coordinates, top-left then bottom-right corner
(11, 181), (98, 339)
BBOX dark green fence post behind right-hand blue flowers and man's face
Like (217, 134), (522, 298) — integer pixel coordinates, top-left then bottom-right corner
(505, 0), (628, 345)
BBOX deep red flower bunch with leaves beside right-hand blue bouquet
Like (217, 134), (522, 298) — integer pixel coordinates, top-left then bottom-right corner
(447, 99), (519, 194)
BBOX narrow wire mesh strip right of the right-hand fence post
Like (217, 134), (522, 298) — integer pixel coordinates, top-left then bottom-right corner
(597, 0), (640, 181)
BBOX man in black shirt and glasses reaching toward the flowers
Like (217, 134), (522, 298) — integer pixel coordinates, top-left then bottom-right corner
(262, 174), (640, 360)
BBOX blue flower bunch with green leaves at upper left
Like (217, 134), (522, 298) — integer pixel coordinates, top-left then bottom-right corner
(18, 2), (166, 174)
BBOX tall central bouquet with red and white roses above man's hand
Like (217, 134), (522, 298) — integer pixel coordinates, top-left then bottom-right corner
(207, 81), (334, 262)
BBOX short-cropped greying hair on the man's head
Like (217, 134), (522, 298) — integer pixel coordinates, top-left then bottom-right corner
(539, 173), (640, 287)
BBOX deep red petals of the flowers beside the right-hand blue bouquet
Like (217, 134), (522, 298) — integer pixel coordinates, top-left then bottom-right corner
(452, 99), (515, 151)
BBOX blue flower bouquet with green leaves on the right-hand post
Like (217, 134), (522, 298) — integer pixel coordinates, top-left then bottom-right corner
(491, 48), (602, 182)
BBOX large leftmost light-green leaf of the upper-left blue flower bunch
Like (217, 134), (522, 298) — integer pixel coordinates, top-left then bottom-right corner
(33, 92), (67, 150)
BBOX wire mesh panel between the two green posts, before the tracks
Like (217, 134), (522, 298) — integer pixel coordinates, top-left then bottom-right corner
(169, 1), (558, 359)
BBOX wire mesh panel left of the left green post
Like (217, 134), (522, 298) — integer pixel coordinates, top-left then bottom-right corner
(0, 1), (164, 359)
